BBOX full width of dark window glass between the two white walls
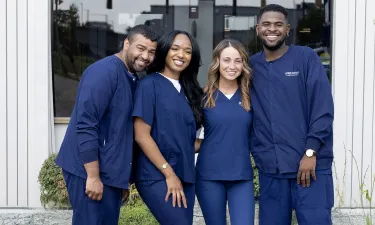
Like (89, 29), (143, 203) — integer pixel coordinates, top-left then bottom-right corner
(51, 0), (332, 117)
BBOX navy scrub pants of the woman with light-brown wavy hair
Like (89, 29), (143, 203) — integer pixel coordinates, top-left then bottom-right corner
(196, 179), (255, 225)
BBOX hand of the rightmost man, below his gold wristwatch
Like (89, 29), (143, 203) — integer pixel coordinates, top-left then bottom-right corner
(297, 155), (316, 187)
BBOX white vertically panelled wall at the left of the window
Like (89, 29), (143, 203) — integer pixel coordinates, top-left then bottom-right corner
(0, 0), (52, 207)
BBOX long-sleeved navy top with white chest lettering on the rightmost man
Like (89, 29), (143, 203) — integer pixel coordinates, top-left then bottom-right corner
(250, 45), (334, 177)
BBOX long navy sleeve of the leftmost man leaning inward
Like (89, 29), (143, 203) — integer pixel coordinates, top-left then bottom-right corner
(76, 66), (117, 164)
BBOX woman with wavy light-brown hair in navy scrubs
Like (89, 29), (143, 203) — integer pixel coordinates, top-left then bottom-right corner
(195, 39), (255, 225)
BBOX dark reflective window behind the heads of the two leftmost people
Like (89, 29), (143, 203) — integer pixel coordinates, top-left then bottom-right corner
(51, 0), (198, 117)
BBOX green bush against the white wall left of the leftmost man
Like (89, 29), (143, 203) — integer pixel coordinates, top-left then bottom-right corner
(38, 154), (71, 208)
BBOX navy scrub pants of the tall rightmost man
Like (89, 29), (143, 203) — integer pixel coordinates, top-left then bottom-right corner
(259, 173), (334, 225)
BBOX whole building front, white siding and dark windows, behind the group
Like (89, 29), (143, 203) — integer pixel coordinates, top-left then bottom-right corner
(0, 0), (375, 208)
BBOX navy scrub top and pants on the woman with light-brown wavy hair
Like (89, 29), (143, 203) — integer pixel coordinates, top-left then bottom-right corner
(196, 89), (255, 225)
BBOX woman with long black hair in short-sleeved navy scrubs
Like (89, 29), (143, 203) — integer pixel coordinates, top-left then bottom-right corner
(133, 31), (203, 225)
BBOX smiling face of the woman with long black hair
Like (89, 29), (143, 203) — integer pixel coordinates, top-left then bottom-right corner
(165, 34), (192, 74)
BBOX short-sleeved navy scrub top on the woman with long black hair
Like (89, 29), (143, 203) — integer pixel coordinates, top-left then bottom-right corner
(133, 73), (196, 183)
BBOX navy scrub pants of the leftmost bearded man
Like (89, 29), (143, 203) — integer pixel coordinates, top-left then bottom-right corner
(63, 171), (123, 225)
